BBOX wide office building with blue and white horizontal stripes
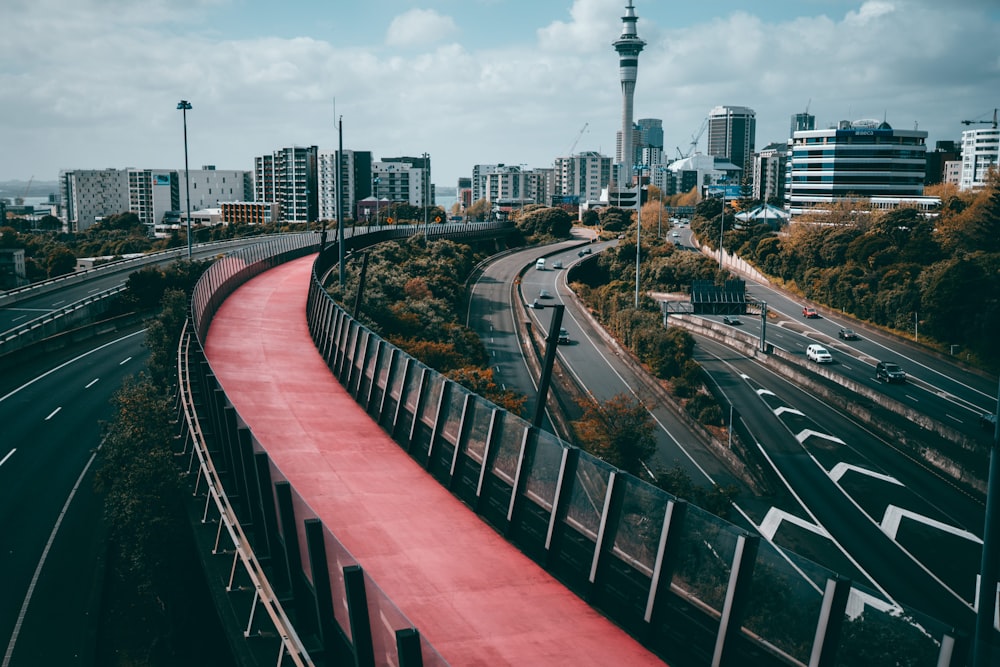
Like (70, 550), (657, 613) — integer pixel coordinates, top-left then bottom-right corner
(785, 120), (940, 215)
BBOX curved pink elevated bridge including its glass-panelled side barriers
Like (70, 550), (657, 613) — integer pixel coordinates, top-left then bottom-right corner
(178, 225), (958, 666)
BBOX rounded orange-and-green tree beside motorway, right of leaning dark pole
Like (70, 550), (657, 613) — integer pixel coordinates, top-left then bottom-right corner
(573, 394), (656, 477)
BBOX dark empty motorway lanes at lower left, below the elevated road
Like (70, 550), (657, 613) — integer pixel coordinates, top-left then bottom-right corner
(0, 330), (147, 667)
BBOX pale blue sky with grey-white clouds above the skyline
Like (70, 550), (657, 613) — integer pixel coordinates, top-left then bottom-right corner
(0, 0), (1000, 186)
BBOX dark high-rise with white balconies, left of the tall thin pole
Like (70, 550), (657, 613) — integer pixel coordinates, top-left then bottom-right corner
(254, 146), (319, 223)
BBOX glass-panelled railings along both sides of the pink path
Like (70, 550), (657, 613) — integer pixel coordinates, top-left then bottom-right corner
(178, 228), (956, 667)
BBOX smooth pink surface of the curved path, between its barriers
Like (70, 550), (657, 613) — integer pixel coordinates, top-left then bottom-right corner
(206, 255), (663, 665)
